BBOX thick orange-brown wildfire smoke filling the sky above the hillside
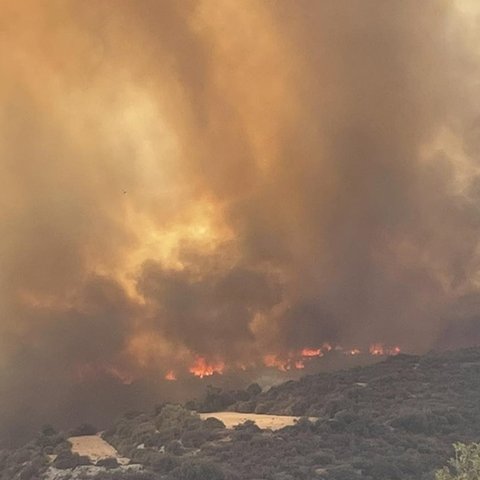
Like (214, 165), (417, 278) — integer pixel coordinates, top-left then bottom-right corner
(0, 0), (480, 441)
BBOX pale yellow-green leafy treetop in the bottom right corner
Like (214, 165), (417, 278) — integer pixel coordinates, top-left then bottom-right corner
(435, 443), (480, 480)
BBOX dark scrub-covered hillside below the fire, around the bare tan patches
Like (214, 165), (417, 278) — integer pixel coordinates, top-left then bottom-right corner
(0, 348), (480, 480)
